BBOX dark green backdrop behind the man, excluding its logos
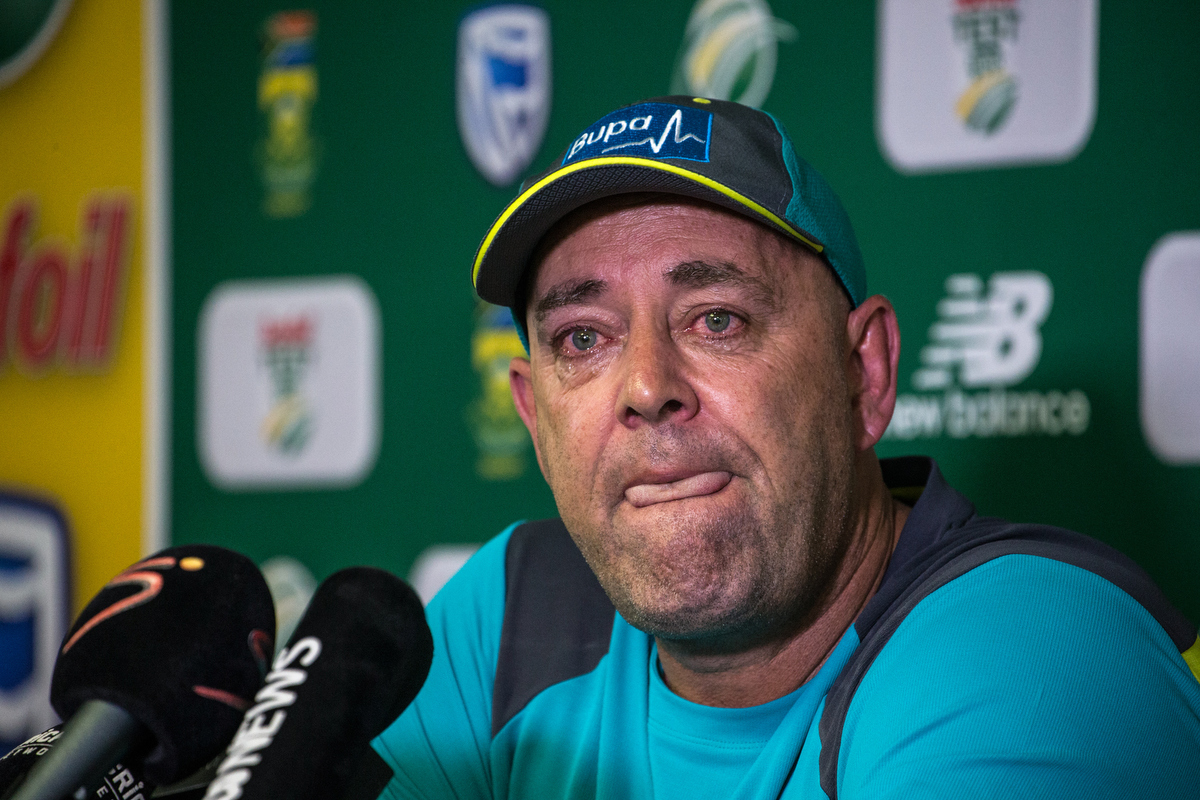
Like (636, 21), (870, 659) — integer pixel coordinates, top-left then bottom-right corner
(169, 0), (1200, 619)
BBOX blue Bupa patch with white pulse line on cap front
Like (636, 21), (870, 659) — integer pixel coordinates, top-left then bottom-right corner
(563, 103), (713, 166)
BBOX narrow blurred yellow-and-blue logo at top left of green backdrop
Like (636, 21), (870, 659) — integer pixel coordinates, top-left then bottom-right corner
(258, 11), (320, 217)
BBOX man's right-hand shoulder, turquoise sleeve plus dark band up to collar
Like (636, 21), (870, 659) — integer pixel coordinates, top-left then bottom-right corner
(821, 459), (1200, 796)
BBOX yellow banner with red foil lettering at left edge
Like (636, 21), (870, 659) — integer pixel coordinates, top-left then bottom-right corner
(0, 0), (146, 609)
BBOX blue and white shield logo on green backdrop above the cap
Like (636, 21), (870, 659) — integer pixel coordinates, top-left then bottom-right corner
(457, 5), (551, 186)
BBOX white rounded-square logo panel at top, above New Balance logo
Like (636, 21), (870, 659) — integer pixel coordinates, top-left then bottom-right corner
(876, 0), (1098, 172)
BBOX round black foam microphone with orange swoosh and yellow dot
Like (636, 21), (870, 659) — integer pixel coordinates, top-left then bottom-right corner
(11, 545), (275, 800)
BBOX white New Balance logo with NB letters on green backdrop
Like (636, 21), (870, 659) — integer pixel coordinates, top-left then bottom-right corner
(884, 272), (1091, 439)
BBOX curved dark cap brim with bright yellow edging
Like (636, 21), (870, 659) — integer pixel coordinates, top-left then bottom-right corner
(472, 156), (824, 307)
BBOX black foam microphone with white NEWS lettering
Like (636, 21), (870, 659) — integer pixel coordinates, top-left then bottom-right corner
(204, 567), (433, 800)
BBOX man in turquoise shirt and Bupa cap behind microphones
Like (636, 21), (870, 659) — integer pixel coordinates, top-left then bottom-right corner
(376, 97), (1200, 799)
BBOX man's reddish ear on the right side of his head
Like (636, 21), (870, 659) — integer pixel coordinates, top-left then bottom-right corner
(846, 295), (900, 450)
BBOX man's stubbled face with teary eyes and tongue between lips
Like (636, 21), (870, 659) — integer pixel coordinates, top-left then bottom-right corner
(512, 201), (856, 648)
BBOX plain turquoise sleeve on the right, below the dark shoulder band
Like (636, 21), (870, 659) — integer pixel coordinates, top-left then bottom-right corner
(835, 554), (1200, 796)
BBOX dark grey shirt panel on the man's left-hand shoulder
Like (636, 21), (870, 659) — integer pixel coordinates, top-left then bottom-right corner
(492, 519), (614, 736)
